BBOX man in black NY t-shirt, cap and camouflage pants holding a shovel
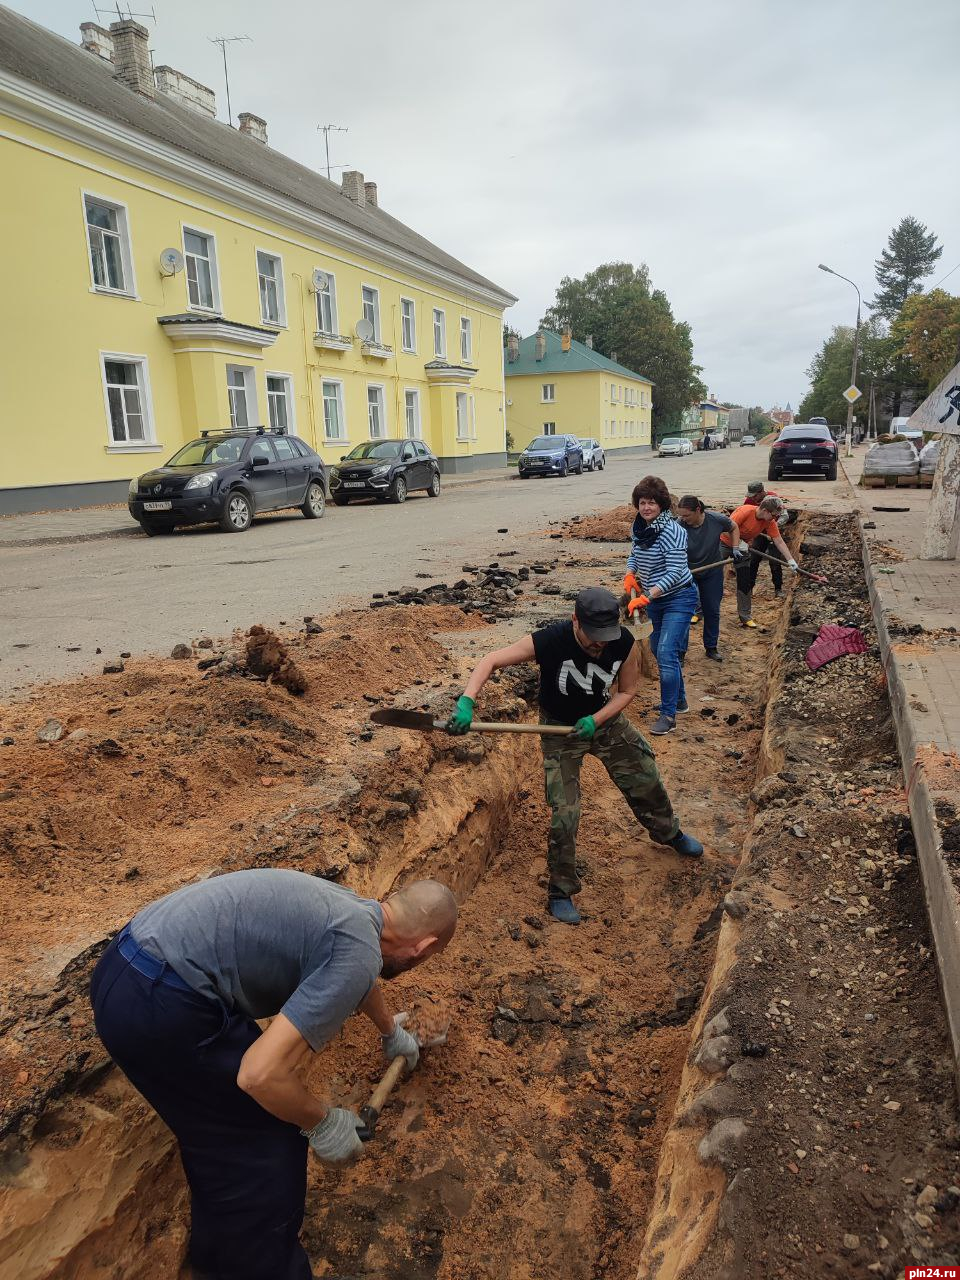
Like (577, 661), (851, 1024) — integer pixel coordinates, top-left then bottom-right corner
(447, 588), (703, 924)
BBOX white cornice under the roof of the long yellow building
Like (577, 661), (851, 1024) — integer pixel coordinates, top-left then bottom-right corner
(0, 70), (517, 310)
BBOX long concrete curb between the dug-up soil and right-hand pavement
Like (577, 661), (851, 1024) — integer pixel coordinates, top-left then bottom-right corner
(860, 519), (960, 1089)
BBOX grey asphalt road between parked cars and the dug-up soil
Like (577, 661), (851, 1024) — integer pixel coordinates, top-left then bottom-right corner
(0, 448), (849, 696)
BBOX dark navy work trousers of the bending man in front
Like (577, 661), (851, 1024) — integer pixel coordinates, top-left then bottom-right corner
(90, 931), (314, 1280)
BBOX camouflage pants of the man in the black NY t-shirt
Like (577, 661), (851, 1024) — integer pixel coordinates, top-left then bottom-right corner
(540, 716), (680, 897)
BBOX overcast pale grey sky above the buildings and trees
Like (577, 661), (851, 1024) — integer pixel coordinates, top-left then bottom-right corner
(30, 0), (960, 408)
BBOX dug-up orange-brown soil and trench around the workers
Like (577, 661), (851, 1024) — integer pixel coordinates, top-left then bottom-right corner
(0, 518), (960, 1280)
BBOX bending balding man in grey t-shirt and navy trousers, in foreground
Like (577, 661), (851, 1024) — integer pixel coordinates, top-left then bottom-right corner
(91, 869), (457, 1280)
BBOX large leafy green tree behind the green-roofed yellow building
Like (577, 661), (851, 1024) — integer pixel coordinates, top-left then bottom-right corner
(540, 262), (707, 440)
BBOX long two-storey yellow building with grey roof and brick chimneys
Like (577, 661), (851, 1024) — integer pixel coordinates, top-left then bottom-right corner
(0, 8), (516, 512)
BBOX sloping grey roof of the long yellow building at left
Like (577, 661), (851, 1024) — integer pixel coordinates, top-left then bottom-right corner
(0, 5), (516, 302)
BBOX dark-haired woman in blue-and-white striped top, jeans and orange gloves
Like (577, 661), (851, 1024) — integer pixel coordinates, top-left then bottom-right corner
(623, 476), (698, 733)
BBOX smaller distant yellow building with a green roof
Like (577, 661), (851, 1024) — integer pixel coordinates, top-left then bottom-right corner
(504, 330), (653, 453)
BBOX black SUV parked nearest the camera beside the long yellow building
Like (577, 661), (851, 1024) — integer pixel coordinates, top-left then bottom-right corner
(127, 426), (326, 538)
